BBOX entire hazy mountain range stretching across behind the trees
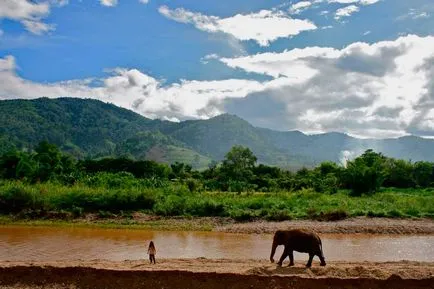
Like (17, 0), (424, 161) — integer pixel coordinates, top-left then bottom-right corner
(0, 98), (434, 169)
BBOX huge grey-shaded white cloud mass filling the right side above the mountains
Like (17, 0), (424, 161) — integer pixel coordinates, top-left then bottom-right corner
(220, 35), (434, 137)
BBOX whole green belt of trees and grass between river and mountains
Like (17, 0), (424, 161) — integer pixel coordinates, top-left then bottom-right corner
(0, 142), (434, 221)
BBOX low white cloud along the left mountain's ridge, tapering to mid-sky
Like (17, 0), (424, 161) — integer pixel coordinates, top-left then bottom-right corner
(0, 56), (263, 120)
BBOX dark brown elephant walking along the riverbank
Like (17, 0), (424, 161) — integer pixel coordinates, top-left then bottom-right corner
(270, 229), (326, 268)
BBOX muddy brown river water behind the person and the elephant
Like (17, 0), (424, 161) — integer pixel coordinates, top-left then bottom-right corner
(0, 226), (434, 262)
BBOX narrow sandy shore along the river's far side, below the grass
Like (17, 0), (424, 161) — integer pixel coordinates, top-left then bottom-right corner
(0, 213), (434, 235)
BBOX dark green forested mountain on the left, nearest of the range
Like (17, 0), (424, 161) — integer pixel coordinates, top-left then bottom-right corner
(0, 98), (211, 167)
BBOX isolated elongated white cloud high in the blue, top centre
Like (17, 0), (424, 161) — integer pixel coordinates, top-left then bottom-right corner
(159, 6), (317, 46)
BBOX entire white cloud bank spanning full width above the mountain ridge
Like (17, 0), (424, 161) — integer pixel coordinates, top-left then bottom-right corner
(0, 35), (434, 138)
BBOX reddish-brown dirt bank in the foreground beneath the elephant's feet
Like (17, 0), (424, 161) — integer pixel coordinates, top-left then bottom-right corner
(0, 259), (434, 289)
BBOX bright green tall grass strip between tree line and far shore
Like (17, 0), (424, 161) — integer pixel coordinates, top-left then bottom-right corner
(0, 181), (434, 221)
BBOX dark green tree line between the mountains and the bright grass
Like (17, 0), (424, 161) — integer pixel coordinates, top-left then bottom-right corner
(0, 141), (434, 196)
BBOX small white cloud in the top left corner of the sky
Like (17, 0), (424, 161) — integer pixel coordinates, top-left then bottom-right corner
(0, 0), (55, 35)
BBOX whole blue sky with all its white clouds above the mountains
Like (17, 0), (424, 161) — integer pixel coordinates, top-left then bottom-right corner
(0, 0), (434, 138)
